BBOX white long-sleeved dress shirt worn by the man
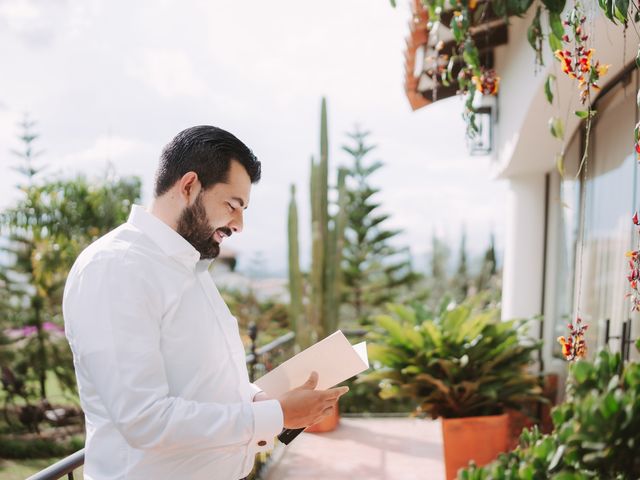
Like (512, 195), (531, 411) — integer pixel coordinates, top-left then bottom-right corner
(63, 206), (283, 480)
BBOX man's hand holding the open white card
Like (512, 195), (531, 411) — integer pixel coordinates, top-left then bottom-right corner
(278, 372), (349, 428)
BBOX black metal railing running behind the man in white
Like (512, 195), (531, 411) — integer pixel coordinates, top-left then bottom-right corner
(27, 324), (296, 480)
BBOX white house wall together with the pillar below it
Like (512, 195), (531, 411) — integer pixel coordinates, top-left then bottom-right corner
(494, 0), (637, 352)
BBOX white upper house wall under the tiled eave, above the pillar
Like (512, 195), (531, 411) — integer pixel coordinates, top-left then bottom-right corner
(494, 0), (637, 178)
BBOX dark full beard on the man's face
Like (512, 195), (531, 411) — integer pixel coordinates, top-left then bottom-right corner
(176, 194), (231, 260)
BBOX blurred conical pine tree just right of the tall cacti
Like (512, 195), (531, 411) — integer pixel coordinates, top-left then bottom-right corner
(342, 128), (419, 324)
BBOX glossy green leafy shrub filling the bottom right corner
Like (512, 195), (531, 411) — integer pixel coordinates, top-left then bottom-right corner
(459, 341), (640, 480)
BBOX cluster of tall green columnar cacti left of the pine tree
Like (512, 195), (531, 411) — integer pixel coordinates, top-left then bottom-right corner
(289, 98), (347, 348)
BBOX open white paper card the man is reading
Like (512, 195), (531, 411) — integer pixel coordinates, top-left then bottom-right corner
(255, 330), (369, 397)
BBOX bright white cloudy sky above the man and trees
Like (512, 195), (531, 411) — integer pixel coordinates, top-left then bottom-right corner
(0, 0), (507, 273)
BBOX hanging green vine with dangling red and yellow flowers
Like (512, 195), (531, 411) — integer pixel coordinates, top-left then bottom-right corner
(391, 0), (640, 361)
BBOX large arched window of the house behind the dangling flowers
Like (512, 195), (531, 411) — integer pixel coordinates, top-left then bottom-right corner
(547, 67), (640, 357)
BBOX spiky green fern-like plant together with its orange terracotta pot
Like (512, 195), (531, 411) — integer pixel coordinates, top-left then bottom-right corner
(363, 303), (545, 479)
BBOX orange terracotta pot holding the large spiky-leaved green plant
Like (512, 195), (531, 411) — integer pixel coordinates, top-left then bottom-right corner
(442, 413), (509, 480)
